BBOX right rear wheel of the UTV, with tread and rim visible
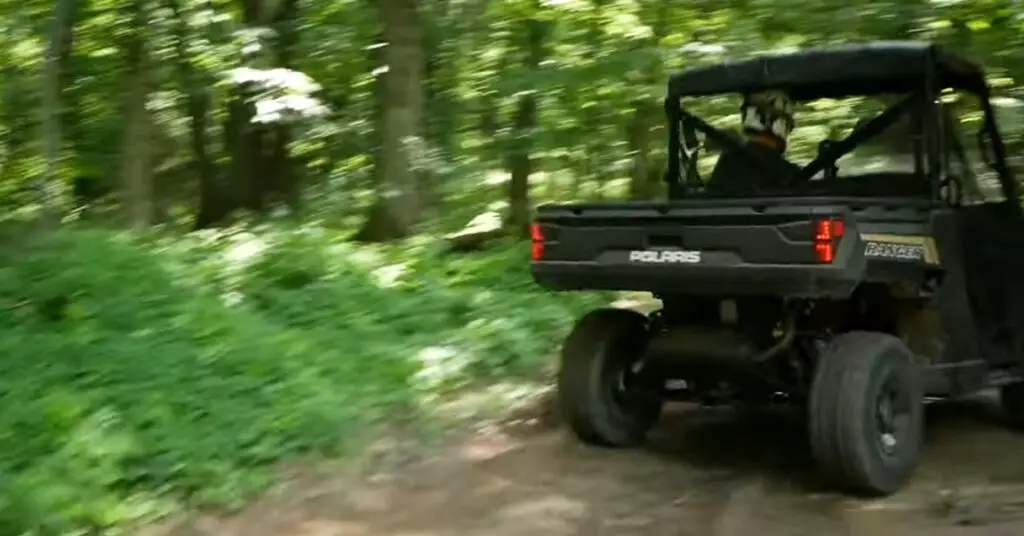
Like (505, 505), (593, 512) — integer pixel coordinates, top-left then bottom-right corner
(808, 332), (924, 496)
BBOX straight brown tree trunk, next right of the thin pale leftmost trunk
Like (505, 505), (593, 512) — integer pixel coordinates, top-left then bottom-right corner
(121, 0), (154, 230)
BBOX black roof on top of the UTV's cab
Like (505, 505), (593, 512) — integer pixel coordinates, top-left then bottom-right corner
(669, 41), (985, 100)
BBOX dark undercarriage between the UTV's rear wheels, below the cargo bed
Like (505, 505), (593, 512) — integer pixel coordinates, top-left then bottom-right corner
(641, 287), (917, 405)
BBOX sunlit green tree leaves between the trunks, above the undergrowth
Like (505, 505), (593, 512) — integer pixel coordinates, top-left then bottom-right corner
(6, 0), (1024, 216)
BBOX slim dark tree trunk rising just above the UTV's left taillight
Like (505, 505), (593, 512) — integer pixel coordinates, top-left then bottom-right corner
(506, 5), (547, 237)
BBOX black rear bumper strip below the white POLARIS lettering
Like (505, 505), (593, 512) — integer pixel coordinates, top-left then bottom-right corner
(531, 257), (864, 298)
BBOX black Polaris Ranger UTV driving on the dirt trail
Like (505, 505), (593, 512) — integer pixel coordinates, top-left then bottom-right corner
(531, 42), (1024, 495)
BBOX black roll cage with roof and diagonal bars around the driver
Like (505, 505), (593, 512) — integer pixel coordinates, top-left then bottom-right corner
(665, 42), (1019, 207)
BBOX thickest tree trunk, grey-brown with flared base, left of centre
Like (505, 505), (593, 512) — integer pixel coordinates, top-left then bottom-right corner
(354, 0), (424, 242)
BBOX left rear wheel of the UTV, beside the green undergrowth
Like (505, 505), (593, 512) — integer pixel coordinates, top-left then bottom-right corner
(558, 308), (663, 447)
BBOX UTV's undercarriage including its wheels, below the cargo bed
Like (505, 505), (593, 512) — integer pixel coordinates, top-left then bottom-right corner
(559, 285), (1024, 495)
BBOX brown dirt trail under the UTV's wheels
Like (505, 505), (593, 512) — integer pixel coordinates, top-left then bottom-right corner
(153, 393), (1024, 536)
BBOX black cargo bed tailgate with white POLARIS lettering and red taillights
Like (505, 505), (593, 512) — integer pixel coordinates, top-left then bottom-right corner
(532, 200), (865, 296)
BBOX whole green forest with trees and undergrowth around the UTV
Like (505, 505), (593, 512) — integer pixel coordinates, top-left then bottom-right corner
(0, 0), (1024, 536)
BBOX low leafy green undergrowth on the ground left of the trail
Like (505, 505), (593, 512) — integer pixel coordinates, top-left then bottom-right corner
(0, 223), (606, 536)
